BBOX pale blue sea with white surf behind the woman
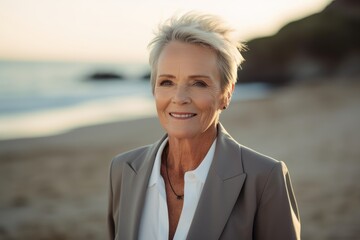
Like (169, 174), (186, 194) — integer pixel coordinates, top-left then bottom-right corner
(0, 61), (268, 139)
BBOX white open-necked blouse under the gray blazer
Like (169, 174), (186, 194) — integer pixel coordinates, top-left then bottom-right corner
(139, 138), (216, 240)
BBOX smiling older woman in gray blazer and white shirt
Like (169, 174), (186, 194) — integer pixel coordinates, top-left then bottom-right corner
(108, 13), (300, 240)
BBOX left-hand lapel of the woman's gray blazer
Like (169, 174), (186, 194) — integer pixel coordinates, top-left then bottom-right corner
(117, 136), (166, 239)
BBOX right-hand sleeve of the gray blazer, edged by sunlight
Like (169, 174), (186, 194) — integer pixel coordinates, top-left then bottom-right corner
(253, 162), (300, 240)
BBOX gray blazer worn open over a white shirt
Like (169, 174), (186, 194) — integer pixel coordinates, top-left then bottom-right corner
(108, 124), (300, 240)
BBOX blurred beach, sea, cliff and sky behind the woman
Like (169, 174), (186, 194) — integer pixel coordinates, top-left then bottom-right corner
(0, 0), (360, 239)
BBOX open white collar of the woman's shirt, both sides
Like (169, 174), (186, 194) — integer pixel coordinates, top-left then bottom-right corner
(148, 137), (217, 187)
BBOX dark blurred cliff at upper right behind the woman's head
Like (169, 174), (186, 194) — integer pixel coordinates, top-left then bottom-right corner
(238, 0), (360, 84)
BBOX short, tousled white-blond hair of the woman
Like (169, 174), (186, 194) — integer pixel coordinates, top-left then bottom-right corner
(148, 12), (244, 92)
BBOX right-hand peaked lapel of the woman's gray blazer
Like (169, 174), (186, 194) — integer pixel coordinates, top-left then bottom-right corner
(187, 123), (246, 239)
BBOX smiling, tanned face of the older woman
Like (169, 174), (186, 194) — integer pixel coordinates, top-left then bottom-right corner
(154, 41), (226, 139)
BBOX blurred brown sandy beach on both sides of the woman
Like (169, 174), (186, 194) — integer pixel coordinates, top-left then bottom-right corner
(0, 79), (360, 240)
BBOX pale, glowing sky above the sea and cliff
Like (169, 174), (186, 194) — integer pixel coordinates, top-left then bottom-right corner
(0, 0), (331, 62)
